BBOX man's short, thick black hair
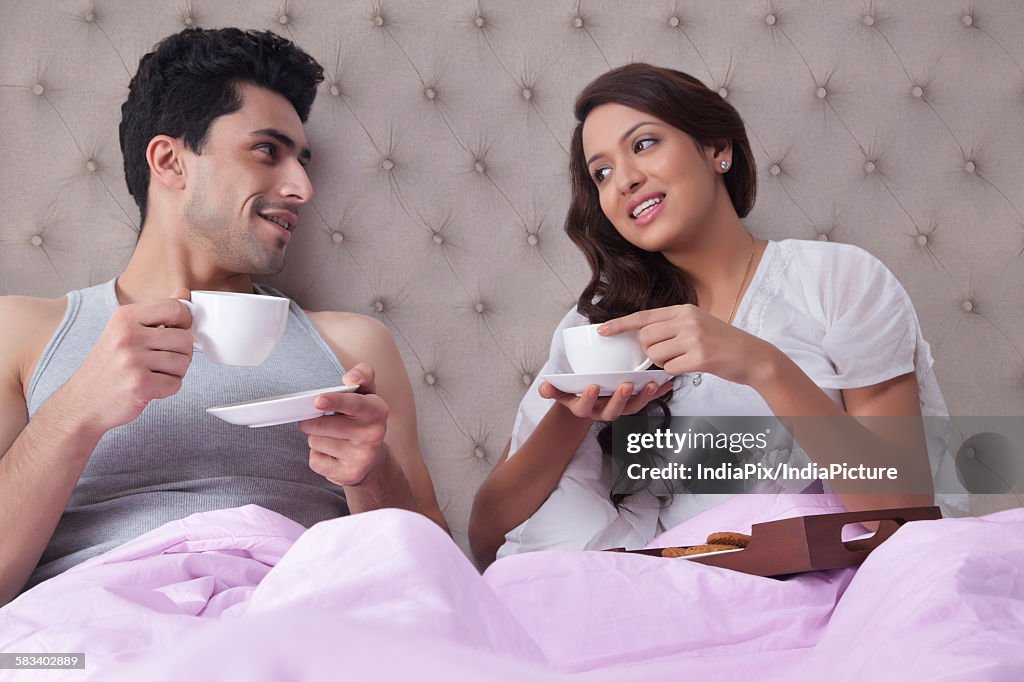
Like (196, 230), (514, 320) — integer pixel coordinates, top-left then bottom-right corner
(118, 29), (324, 221)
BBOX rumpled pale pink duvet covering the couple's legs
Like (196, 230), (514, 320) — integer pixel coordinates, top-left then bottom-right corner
(0, 496), (1024, 682)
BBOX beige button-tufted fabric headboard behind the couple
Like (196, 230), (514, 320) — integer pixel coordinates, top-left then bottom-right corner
(0, 0), (1024, 547)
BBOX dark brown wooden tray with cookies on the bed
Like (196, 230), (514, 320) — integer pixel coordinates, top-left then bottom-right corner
(608, 507), (942, 578)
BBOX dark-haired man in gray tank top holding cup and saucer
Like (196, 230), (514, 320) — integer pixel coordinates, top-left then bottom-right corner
(0, 29), (444, 604)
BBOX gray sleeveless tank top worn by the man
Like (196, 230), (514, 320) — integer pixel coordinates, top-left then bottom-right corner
(28, 280), (348, 587)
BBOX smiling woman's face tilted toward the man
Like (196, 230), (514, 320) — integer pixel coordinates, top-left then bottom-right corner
(583, 104), (732, 252)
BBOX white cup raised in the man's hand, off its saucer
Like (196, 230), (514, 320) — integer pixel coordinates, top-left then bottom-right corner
(178, 291), (289, 367)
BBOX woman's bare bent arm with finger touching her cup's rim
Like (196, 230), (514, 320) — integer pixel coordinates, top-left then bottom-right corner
(601, 305), (932, 511)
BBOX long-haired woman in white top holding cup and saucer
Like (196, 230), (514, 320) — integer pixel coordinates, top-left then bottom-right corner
(469, 63), (945, 564)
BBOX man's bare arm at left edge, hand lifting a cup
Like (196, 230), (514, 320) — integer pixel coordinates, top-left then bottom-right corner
(0, 296), (191, 604)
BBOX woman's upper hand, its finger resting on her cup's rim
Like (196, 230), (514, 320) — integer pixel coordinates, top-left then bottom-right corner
(599, 304), (777, 385)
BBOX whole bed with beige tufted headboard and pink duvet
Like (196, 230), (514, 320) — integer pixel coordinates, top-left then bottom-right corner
(0, 0), (1024, 681)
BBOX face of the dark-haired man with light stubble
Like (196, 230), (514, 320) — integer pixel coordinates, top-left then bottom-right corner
(184, 84), (313, 274)
